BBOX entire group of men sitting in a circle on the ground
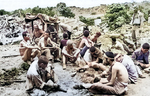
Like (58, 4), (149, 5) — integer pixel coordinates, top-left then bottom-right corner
(20, 26), (150, 95)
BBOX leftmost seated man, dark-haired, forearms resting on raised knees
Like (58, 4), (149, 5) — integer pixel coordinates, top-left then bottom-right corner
(19, 31), (40, 62)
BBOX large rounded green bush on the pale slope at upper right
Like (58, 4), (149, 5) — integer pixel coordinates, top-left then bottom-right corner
(104, 4), (131, 30)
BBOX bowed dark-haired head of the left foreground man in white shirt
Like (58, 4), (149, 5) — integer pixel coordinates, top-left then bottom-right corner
(38, 56), (48, 69)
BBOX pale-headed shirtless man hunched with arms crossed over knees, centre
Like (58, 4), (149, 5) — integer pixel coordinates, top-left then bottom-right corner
(62, 40), (80, 69)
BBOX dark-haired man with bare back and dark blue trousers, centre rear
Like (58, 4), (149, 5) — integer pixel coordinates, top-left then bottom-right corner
(78, 30), (94, 57)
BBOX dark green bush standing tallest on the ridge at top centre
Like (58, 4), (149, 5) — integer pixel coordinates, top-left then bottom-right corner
(57, 2), (75, 18)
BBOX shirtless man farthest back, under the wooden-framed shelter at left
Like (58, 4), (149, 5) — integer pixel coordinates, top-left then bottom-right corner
(33, 25), (45, 44)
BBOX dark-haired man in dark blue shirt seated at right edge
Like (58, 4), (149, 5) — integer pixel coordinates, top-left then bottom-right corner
(132, 43), (150, 78)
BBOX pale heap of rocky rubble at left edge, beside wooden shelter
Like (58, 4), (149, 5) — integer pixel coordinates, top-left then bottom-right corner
(0, 15), (24, 45)
